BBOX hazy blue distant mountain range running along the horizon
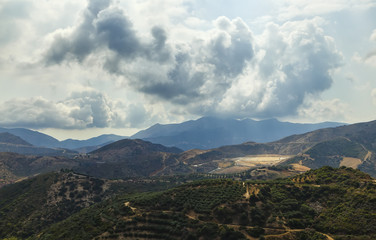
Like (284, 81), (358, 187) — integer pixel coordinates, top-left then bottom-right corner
(0, 117), (344, 153)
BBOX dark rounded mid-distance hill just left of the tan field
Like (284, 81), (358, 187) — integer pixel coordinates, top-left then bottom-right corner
(75, 139), (191, 179)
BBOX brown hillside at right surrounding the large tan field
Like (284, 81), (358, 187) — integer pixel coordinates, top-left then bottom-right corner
(179, 121), (376, 176)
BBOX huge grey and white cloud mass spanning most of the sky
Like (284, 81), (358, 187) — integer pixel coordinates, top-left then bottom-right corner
(39, 1), (342, 126)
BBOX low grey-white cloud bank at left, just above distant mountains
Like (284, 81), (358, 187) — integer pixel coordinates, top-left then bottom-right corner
(0, 90), (149, 129)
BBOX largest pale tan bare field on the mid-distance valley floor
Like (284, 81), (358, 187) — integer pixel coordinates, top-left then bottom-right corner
(212, 154), (292, 174)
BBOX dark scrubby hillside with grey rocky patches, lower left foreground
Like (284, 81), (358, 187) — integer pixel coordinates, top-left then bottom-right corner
(0, 172), (113, 239)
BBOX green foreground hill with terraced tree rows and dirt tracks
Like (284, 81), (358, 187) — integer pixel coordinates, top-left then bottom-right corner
(0, 167), (376, 240)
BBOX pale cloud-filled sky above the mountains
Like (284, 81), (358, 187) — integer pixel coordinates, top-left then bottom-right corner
(0, 0), (376, 140)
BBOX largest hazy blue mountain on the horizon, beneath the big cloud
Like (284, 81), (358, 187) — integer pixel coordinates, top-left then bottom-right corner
(131, 117), (343, 150)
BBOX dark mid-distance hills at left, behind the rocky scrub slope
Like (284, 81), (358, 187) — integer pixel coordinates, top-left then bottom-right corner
(0, 139), (194, 186)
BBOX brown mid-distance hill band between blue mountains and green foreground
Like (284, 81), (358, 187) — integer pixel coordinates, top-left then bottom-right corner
(0, 118), (376, 182)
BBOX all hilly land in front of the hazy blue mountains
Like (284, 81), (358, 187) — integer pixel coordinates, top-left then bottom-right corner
(0, 121), (376, 240)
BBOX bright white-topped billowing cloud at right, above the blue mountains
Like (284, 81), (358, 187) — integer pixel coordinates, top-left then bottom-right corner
(210, 19), (342, 118)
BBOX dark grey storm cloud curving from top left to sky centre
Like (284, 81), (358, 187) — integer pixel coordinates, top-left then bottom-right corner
(46, 1), (253, 104)
